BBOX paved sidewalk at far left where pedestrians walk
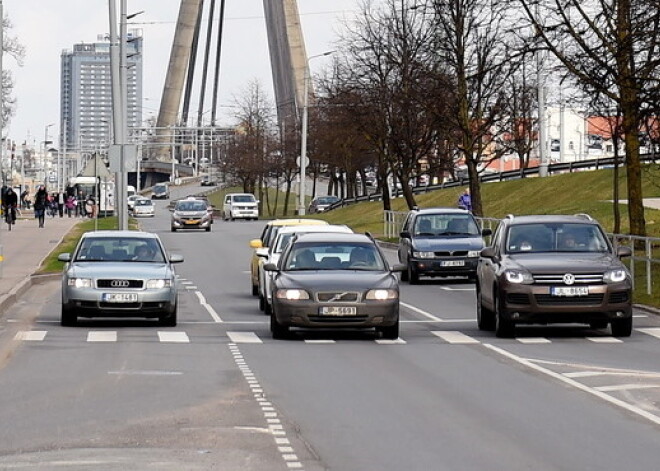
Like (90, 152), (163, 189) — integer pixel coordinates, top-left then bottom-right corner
(0, 213), (82, 315)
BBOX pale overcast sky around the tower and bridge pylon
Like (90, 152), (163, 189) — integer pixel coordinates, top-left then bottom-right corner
(3, 0), (360, 148)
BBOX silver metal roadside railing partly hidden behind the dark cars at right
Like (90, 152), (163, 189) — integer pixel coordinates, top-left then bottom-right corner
(383, 211), (660, 295)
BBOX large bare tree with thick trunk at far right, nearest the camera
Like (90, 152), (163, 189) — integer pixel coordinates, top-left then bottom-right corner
(518, 0), (660, 235)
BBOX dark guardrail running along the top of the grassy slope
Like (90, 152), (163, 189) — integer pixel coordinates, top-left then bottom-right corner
(326, 154), (660, 211)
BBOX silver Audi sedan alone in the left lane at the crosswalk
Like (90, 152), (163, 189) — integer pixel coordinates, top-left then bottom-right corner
(58, 231), (183, 326)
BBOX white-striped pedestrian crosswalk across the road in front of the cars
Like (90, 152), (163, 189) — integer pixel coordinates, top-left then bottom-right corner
(9, 328), (660, 345)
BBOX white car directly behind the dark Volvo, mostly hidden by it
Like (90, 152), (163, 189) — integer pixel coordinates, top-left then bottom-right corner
(256, 224), (353, 314)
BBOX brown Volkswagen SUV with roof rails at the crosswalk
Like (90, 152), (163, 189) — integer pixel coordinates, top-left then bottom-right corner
(477, 215), (632, 337)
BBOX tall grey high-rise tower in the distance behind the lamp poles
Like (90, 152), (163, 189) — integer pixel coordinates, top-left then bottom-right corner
(60, 29), (142, 153)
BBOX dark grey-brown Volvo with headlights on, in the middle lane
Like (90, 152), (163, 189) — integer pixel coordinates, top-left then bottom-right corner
(264, 233), (403, 339)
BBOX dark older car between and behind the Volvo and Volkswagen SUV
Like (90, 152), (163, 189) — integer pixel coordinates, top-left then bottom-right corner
(398, 208), (491, 284)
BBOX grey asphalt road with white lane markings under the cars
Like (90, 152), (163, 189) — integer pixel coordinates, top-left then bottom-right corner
(0, 184), (660, 471)
